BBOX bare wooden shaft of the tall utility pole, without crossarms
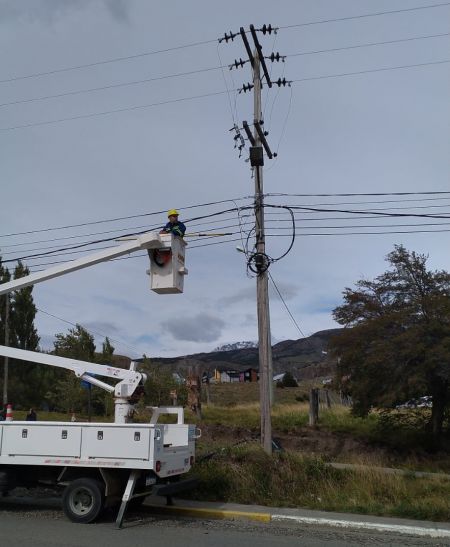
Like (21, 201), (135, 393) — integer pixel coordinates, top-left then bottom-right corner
(253, 51), (272, 454)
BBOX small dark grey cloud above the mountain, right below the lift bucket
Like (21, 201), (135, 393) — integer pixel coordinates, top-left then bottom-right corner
(162, 313), (225, 342)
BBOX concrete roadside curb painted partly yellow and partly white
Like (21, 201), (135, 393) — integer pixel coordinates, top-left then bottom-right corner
(145, 503), (450, 538)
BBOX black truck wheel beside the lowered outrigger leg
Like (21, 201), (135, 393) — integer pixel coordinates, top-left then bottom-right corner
(63, 478), (105, 524)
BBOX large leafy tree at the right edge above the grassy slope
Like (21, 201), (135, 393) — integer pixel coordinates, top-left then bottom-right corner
(332, 245), (450, 441)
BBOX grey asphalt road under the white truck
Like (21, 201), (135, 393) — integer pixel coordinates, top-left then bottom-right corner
(0, 497), (450, 547)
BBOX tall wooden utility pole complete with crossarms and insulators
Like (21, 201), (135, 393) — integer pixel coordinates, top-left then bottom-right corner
(219, 25), (290, 454)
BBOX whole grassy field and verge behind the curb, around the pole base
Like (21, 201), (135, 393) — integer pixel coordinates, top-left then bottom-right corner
(6, 384), (450, 521)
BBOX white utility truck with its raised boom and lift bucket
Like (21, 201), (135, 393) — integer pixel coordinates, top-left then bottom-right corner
(0, 233), (200, 527)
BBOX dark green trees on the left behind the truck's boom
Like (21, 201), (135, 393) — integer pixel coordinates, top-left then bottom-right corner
(0, 257), (187, 416)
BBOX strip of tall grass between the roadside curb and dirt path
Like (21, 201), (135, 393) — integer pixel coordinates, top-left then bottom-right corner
(187, 444), (450, 521)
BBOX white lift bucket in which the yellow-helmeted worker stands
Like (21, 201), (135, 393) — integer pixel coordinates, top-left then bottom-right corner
(148, 234), (188, 294)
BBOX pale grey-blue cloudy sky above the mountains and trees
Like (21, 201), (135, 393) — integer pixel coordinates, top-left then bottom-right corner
(0, 0), (450, 357)
